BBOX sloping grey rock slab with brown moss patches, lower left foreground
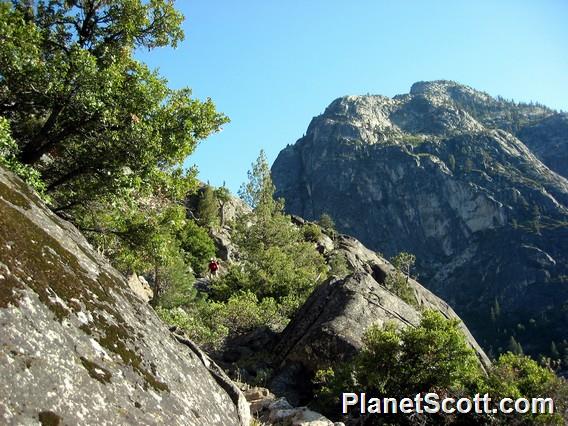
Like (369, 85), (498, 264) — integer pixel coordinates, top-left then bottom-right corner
(0, 168), (250, 426)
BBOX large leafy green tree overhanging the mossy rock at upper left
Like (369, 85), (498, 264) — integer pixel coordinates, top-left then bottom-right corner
(0, 0), (226, 211)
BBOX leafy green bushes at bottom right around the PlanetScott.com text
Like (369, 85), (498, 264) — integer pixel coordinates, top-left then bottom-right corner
(315, 311), (568, 425)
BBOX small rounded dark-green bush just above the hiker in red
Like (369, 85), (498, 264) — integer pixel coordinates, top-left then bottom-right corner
(178, 220), (215, 273)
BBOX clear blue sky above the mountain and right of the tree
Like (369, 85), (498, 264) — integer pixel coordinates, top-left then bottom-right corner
(139, 0), (568, 192)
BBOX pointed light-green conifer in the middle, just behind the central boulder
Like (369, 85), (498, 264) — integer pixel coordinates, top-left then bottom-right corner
(214, 152), (327, 316)
